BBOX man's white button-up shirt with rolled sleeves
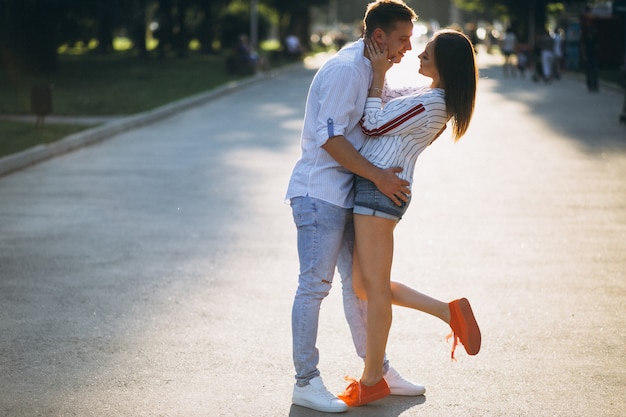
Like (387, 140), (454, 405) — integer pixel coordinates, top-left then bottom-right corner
(286, 39), (372, 208)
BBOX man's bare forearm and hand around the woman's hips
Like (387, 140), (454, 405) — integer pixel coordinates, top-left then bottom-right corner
(322, 135), (411, 205)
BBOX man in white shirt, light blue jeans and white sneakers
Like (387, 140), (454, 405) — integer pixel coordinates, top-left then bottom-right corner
(286, 0), (425, 412)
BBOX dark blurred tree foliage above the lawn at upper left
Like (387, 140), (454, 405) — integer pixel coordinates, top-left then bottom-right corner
(0, 0), (328, 73)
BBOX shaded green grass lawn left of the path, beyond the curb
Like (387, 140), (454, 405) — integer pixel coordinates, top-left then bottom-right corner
(0, 53), (260, 157)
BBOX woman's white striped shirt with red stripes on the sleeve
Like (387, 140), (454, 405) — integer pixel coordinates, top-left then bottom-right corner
(360, 87), (448, 187)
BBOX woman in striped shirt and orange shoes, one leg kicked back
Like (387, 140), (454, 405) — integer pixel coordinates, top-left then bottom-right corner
(338, 30), (481, 406)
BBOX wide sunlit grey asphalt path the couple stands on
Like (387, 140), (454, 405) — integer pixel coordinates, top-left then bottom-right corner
(0, 47), (626, 417)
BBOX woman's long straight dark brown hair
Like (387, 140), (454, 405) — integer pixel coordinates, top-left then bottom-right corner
(434, 29), (478, 142)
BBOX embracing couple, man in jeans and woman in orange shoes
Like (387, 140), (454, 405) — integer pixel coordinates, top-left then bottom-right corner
(286, 0), (481, 412)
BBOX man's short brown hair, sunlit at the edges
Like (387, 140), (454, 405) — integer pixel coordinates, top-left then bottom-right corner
(363, 0), (417, 38)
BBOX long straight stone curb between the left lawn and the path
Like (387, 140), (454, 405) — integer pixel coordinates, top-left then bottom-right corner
(0, 70), (278, 177)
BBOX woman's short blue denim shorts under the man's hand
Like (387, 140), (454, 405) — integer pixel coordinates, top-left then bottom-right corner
(354, 175), (411, 220)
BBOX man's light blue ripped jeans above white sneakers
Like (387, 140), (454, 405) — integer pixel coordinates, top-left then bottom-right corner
(291, 196), (389, 386)
